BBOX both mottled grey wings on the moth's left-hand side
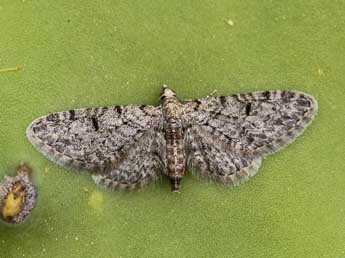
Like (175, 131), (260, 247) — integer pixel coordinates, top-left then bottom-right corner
(27, 105), (163, 188)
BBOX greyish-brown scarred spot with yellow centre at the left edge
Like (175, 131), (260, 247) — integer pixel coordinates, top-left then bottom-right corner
(0, 163), (37, 224)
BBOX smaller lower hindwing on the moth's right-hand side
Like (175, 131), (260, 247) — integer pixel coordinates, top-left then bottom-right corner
(186, 126), (261, 185)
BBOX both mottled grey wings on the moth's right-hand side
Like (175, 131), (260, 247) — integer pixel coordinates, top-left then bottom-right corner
(183, 90), (317, 185)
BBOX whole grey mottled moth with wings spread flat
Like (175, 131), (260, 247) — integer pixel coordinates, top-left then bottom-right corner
(27, 86), (317, 192)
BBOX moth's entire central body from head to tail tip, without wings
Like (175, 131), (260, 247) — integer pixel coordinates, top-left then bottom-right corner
(161, 88), (185, 191)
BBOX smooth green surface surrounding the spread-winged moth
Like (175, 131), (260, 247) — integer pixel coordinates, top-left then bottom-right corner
(0, 0), (345, 258)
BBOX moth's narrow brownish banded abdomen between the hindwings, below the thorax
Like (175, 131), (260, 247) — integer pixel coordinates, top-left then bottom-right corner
(165, 120), (185, 191)
